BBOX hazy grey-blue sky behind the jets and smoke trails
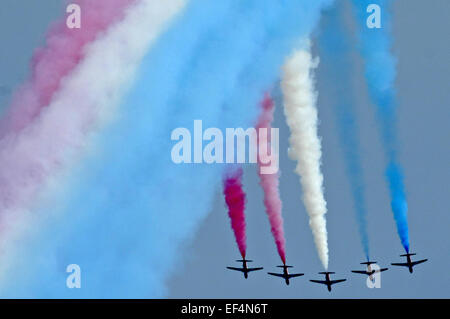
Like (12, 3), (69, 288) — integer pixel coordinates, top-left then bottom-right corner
(0, 0), (450, 298)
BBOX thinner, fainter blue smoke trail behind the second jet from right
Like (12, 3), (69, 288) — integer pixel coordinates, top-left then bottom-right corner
(319, 5), (369, 260)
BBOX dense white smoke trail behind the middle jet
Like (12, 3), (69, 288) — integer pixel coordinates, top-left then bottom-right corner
(281, 49), (328, 269)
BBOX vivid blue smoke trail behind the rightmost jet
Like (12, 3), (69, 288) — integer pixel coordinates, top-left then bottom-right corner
(353, 0), (409, 252)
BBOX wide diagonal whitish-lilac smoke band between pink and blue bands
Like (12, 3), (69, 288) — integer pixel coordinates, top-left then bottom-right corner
(0, 0), (184, 264)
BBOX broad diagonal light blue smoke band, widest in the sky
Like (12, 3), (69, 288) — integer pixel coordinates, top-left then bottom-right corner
(2, 0), (330, 298)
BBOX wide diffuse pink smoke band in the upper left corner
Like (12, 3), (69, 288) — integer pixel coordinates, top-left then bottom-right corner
(0, 0), (135, 138)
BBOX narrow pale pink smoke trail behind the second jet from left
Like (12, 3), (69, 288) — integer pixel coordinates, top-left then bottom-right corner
(256, 94), (286, 264)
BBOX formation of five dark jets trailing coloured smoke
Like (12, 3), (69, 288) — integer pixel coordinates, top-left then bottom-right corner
(227, 253), (428, 292)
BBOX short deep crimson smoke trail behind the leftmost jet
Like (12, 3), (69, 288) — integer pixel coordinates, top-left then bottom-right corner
(223, 167), (247, 258)
